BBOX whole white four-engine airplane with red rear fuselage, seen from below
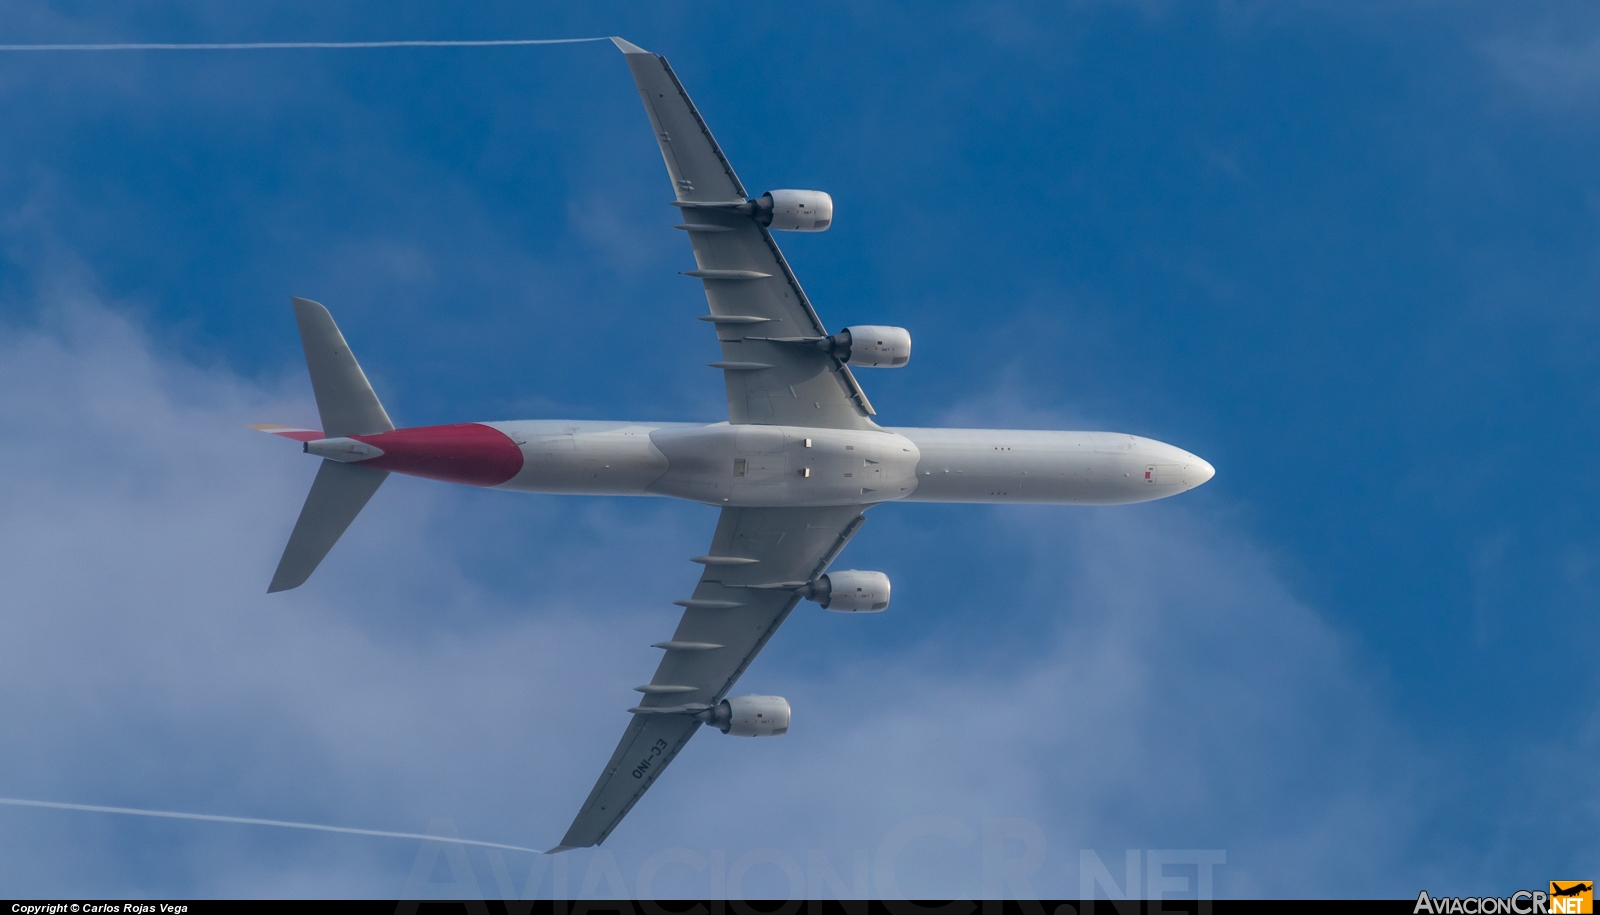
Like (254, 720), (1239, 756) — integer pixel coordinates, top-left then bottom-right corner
(253, 38), (1214, 853)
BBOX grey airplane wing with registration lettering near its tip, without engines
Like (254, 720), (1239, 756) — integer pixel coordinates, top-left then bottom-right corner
(550, 505), (866, 851)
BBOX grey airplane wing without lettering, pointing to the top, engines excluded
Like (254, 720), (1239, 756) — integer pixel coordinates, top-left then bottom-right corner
(611, 38), (877, 429)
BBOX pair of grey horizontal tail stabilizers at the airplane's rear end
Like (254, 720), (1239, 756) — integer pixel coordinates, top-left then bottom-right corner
(265, 299), (395, 593)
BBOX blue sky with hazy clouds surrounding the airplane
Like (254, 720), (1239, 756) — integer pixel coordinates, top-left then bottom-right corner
(0, 0), (1600, 896)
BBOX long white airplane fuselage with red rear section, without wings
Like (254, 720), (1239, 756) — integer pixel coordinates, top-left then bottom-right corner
(307, 419), (1213, 507)
